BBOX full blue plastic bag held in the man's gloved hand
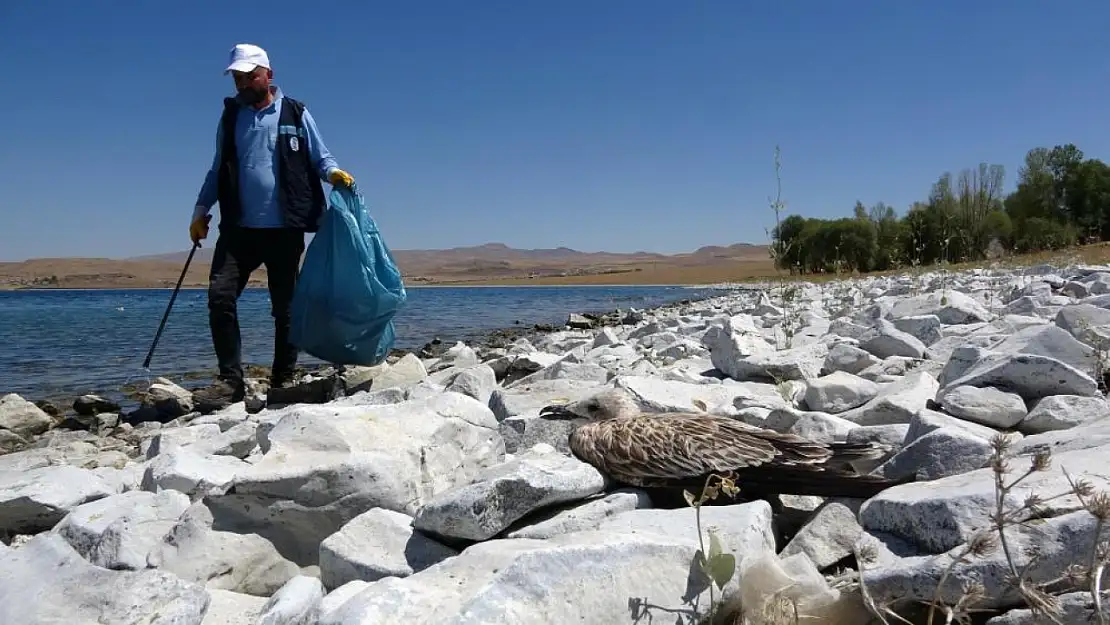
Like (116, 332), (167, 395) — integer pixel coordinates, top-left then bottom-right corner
(290, 187), (407, 365)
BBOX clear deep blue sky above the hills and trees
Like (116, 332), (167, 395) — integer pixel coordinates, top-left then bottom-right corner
(0, 0), (1110, 260)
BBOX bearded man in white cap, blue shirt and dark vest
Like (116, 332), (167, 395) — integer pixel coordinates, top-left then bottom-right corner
(189, 43), (354, 412)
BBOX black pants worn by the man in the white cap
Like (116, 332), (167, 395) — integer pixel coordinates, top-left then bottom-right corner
(209, 228), (304, 384)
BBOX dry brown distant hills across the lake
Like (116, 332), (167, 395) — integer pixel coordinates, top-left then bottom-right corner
(0, 242), (769, 289)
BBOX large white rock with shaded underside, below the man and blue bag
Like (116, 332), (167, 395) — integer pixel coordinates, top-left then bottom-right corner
(208, 393), (505, 565)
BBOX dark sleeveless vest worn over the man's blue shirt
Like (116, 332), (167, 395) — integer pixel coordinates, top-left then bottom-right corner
(216, 97), (326, 232)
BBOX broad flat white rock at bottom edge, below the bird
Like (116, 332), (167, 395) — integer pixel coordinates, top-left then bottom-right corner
(320, 531), (750, 625)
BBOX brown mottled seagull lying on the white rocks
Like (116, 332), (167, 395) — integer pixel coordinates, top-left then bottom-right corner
(539, 389), (911, 498)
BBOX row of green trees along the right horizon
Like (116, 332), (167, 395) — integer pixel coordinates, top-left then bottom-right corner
(774, 143), (1110, 278)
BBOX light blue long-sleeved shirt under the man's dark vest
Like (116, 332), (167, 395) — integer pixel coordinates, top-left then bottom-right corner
(193, 88), (339, 228)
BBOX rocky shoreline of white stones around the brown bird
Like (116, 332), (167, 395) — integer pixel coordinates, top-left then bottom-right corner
(0, 266), (1110, 625)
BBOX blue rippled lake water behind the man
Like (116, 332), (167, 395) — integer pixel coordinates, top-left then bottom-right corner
(0, 286), (715, 401)
